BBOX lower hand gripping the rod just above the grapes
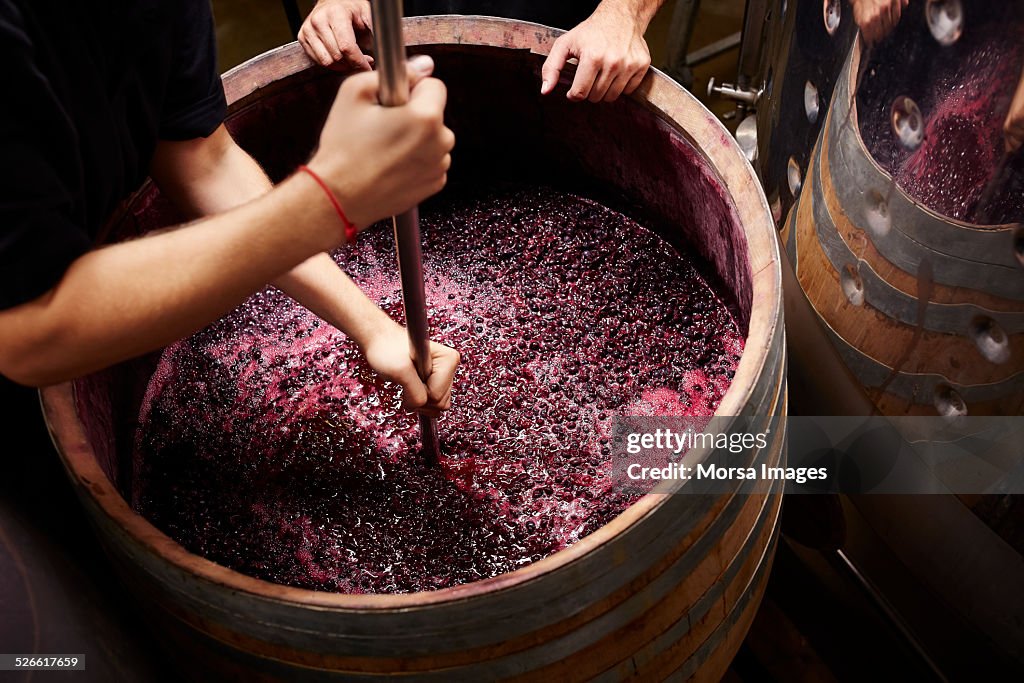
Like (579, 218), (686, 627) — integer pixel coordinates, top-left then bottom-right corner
(364, 325), (461, 418)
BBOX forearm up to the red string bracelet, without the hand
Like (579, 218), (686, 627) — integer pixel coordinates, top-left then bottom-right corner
(0, 178), (340, 385)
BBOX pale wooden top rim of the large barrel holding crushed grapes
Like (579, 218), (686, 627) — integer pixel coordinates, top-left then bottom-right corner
(40, 15), (784, 611)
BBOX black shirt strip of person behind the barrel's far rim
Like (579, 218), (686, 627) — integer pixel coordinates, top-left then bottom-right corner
(404, 0), (598, 30)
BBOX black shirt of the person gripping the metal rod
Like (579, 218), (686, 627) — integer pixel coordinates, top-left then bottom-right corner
(0, 0), (226, 308)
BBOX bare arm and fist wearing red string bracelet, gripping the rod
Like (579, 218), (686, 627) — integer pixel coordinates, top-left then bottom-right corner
(0, 63), (454, 386)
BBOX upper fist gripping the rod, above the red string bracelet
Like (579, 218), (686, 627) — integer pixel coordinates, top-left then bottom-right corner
(308, 55), (455, 237)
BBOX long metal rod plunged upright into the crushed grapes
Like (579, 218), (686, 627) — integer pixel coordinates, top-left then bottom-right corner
(371, 0), (440, 462)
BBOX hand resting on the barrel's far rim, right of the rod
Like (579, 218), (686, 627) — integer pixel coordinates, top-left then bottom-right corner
(541, 0), (664, 102)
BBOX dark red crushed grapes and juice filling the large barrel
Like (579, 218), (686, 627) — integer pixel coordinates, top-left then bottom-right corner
(133, 188), (742, 593)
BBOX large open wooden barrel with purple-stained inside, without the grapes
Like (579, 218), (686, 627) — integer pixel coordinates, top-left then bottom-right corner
(42, 17), (785, 681)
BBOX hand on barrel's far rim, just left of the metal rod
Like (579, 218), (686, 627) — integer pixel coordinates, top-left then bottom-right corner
(299, 0), (374, 71)
